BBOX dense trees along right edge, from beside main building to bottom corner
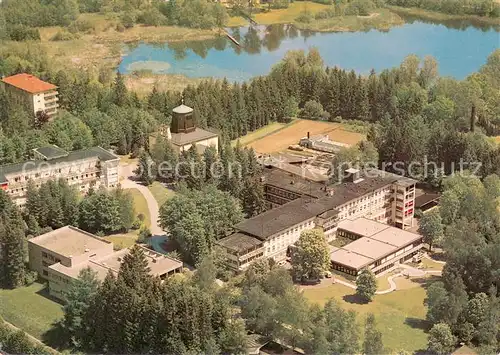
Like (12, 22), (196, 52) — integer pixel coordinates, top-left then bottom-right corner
(423, 175), (500, 354)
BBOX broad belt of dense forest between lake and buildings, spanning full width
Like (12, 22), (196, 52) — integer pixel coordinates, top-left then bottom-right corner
(0, 46), (500, 182)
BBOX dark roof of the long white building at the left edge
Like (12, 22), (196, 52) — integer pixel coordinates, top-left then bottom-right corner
(0, 147), (120, 183)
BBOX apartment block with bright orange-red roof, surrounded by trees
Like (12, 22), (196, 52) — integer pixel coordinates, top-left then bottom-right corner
(2, 73), (59, 117)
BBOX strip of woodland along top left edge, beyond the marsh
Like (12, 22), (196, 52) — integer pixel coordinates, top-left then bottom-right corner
(0, 0), (228, 41)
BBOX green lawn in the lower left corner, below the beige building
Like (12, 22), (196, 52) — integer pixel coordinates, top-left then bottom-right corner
(0, 283), (63, 339)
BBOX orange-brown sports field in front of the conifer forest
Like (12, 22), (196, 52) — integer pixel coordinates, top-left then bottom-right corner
(248, 120), (366, 154)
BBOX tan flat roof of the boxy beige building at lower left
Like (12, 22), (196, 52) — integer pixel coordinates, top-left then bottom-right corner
(29, 226), (111, 258)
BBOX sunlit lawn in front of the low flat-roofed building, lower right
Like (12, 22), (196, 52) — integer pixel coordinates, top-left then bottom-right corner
(304, 279), (428, 352)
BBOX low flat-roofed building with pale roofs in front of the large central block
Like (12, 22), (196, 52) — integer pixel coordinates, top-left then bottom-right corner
(330, 218), (423, 276)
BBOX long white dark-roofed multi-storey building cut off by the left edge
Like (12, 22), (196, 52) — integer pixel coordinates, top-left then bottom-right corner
(0, 146), (120, 205)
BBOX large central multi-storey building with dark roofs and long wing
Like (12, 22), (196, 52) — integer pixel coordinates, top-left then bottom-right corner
(218, 169), (416, 270)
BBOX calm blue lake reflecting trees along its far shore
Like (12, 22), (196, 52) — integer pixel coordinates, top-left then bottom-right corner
(119, 19), (500, 81)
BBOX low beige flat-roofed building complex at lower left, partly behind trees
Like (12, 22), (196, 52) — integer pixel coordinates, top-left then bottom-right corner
(28, 226), (182, 300)
